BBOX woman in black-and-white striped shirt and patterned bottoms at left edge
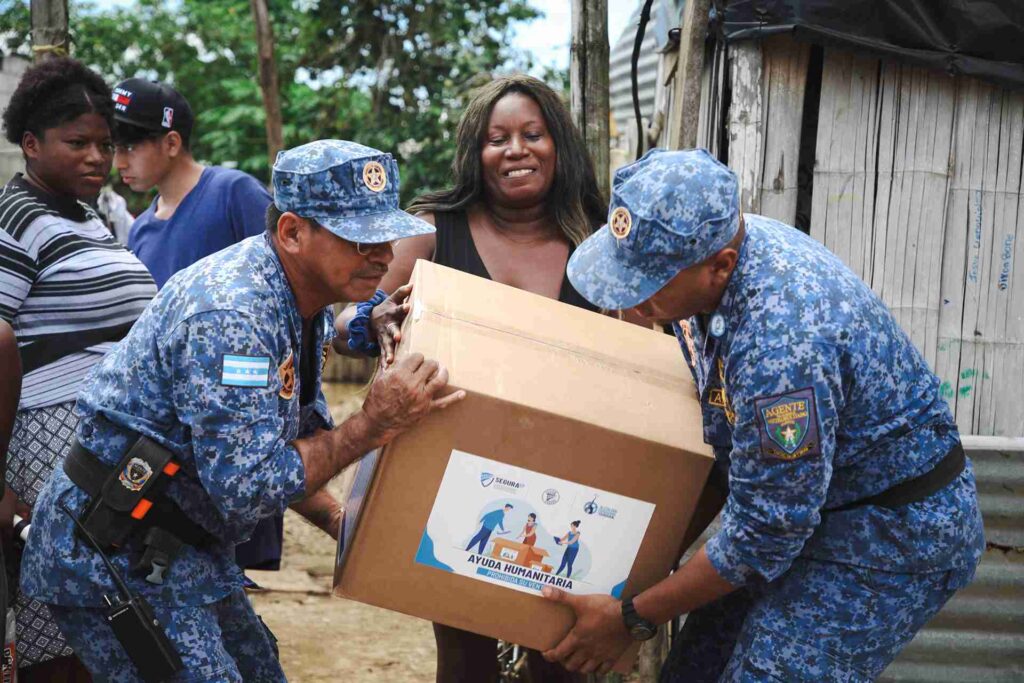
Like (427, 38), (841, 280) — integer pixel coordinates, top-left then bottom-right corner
(0, 57), (157, 681)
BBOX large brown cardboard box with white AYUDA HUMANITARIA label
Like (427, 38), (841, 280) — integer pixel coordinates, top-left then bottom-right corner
(334, 261), (714, 669)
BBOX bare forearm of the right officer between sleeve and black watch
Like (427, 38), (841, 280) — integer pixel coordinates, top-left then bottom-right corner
(633, 548), (737, 624)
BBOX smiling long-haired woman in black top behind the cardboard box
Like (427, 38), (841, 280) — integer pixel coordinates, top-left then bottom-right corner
(335, 76), (607, 683)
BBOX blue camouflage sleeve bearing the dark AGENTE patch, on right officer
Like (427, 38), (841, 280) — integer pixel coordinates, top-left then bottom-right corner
(706, 342), (843, 586)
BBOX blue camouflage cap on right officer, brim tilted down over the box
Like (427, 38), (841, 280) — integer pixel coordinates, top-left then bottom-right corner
(567, 150), (739, 309)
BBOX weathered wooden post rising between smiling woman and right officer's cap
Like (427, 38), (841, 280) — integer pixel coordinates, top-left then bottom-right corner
(569, 0), (609, 200)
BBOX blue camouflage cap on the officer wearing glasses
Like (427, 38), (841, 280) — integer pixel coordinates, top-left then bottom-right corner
(273, 140), (434, 244)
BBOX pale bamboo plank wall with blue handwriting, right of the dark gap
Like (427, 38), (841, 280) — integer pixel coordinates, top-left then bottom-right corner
(806, 50), (1024, 436)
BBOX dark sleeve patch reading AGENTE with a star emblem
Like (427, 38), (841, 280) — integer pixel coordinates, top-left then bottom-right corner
(754, 387), (821, 460)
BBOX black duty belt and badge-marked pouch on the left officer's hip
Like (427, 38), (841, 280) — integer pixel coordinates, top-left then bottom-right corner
(63, 436), (215, 584)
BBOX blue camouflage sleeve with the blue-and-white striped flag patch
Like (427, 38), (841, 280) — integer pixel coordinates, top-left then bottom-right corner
(172, 311), (305, 526)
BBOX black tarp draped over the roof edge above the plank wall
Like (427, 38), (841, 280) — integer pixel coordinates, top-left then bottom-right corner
(712, 0), (1024, 88)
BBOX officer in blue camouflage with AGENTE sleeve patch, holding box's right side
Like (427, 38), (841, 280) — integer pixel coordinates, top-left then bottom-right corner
(546, 150), (984, 681)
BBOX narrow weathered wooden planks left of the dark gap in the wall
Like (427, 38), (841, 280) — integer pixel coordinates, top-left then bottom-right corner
(728, 36), (810, 223)
